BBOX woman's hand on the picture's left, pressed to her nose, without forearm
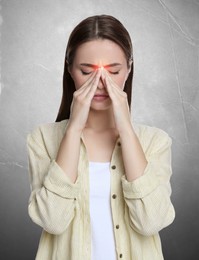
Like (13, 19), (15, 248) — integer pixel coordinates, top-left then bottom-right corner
(68, 69), (101, 133)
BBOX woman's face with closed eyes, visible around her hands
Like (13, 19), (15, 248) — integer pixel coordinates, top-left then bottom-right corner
(70, 39), (130, 109)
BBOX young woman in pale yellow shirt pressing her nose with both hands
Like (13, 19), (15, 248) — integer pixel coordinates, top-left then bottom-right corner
(28, 15), (175, 260)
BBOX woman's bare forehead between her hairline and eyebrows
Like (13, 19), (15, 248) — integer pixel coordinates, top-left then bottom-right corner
(74, 39), (126, 65)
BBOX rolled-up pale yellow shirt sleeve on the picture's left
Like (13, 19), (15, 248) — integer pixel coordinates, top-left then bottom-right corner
(27, 129), (80, 234)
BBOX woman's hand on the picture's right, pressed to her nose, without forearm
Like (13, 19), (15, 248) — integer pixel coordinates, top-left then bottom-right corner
(102, 68), (131, 134)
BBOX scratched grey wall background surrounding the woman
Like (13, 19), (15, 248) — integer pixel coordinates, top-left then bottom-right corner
(0, 0), (199, 260)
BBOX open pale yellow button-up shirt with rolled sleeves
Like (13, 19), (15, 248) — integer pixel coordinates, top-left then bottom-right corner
(27, 120), (175, 260)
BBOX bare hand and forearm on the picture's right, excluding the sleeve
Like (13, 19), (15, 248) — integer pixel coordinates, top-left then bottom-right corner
(102, 70), (147, 182)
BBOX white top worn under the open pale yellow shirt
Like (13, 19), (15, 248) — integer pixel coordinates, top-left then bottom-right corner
(89, 162), (117, 260)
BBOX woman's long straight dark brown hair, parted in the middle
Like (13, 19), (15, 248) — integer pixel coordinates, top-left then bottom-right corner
(56, 15), (133, 122)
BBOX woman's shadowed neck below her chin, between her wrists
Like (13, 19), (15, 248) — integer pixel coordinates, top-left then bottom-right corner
(86, 108), (115, 132)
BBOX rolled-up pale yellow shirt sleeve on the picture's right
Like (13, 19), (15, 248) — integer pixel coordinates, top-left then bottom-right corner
(122, 131), (175, 236)
